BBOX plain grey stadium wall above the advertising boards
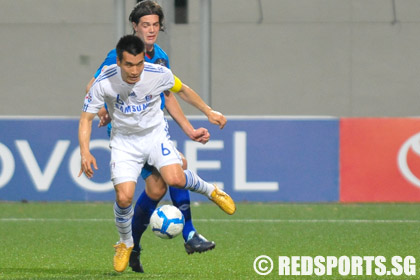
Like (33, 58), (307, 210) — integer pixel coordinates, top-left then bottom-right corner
(0, 0), (420, 117)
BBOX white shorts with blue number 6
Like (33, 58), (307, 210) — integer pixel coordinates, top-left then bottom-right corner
(110, 124), (182, 186)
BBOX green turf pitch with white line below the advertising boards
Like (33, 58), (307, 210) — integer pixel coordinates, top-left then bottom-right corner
(0, 202), (420, 279)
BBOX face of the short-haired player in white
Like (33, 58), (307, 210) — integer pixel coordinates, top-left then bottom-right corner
(117, 52), (144, 84)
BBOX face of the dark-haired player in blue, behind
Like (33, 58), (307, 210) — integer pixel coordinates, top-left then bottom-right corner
(133, 15), (160, 48)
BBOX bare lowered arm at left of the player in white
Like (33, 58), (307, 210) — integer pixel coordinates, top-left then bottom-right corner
(78, 112), (98, 178)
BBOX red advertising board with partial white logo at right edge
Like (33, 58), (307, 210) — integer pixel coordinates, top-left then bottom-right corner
(340, 118), (420, 202)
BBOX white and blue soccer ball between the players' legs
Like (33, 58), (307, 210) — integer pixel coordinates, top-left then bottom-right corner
(150, 205), (185, 239)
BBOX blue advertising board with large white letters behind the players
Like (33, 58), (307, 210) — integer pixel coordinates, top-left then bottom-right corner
(0, 117), (339, 202)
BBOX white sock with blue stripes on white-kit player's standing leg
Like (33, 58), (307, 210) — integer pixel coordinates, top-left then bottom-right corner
(114, 202), (134, 247)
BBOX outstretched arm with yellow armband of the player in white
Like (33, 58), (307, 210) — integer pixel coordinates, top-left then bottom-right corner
(171, 75), (227, 129)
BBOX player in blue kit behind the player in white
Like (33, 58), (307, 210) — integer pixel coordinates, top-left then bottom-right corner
(88, 1), (226, 272)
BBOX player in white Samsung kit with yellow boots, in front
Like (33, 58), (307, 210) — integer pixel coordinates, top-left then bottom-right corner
(79, 35), (236, 272)
